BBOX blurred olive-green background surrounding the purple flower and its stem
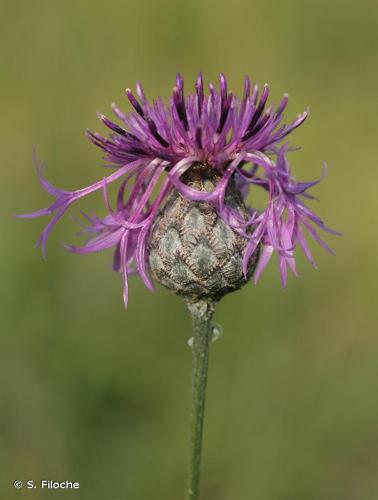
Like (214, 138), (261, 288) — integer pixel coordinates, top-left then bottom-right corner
(0, 0), (378, 500)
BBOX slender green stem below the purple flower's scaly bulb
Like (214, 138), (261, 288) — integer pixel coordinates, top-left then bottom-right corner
(185, 300), (214, 500)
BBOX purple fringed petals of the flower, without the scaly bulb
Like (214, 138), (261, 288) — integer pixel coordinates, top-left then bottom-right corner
(20, 74), (338, 305)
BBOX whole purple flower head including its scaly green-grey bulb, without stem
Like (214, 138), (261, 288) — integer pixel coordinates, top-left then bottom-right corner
(21, 74), (337, 305)
